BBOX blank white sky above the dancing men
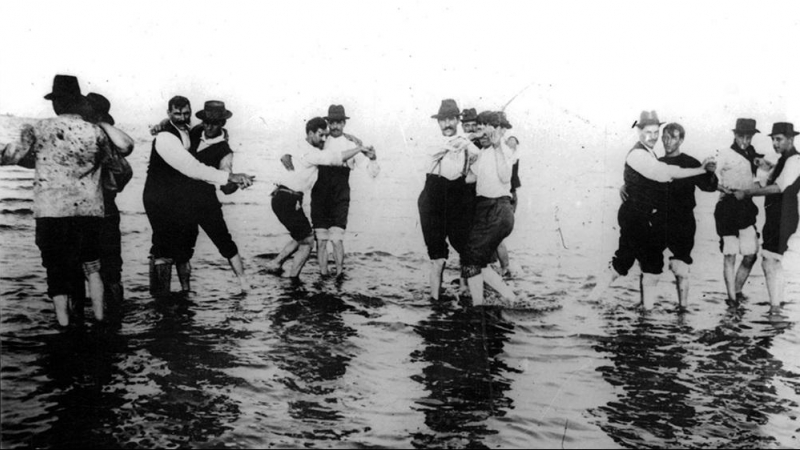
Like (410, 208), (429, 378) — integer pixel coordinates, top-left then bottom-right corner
(0, 0), (800, 151)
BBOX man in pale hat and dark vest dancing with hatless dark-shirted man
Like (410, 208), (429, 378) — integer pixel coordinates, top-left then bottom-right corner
(590, 111), (716, 310)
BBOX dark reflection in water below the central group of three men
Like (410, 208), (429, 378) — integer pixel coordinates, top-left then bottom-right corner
(411, 308), (516, 448)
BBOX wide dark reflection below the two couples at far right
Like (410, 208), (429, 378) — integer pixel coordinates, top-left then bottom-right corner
(592, 313), (790, 448)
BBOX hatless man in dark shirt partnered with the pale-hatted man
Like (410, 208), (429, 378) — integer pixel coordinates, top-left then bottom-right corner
(659, 122), (717, 310)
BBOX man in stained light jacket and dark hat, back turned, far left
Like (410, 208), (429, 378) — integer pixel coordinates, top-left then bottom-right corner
(0, 75), (109, 326)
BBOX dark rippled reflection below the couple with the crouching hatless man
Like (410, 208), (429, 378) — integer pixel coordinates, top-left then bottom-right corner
(269, 289), (357, 440)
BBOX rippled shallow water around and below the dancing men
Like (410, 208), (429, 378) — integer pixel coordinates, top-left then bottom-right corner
(0, 120), (800, 448)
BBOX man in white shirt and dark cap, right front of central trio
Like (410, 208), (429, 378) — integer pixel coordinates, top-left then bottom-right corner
(461, 111), (517, 306)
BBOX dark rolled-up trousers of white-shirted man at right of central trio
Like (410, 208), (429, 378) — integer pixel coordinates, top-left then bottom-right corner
(461, 197), (514, 278)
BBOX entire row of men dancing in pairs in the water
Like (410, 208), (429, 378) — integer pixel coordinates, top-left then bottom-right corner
(0, 75), (800, 325)
